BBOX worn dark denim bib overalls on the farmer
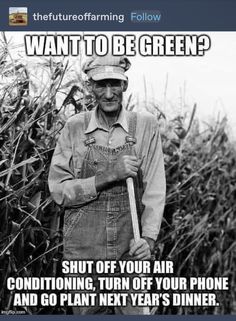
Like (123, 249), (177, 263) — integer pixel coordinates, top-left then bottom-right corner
(64, 112), (142, 260)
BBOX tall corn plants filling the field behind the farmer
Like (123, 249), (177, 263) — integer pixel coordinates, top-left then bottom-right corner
(0, 34), (236, 314)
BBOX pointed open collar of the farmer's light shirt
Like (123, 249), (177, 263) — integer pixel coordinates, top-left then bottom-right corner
(85, 106), (129, 134)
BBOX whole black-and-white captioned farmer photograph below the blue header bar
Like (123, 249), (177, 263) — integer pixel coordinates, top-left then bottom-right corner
(0, 31), (236, 316)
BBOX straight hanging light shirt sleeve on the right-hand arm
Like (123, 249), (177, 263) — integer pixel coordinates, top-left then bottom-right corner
(141, 122), (166, 240)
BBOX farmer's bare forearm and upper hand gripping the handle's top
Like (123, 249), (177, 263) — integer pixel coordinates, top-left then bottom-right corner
(95, 155), (141, 192)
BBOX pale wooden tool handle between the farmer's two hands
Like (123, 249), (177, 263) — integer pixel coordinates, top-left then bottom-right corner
(126, 177), (140, 242)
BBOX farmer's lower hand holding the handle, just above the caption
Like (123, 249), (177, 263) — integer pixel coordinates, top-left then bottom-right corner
(129, 238), (151, 260)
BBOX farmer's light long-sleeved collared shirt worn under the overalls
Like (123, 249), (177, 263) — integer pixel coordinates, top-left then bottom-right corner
(48, 108), (166, 240)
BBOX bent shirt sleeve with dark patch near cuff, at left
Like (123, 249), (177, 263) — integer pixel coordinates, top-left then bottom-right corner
(48, 122), (97, 207)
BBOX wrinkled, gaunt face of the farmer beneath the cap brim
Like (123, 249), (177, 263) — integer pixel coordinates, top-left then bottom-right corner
(92, 79), (124, 114)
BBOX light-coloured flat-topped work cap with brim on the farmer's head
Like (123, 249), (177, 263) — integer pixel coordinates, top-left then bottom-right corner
(82, 54), (131, 81)
